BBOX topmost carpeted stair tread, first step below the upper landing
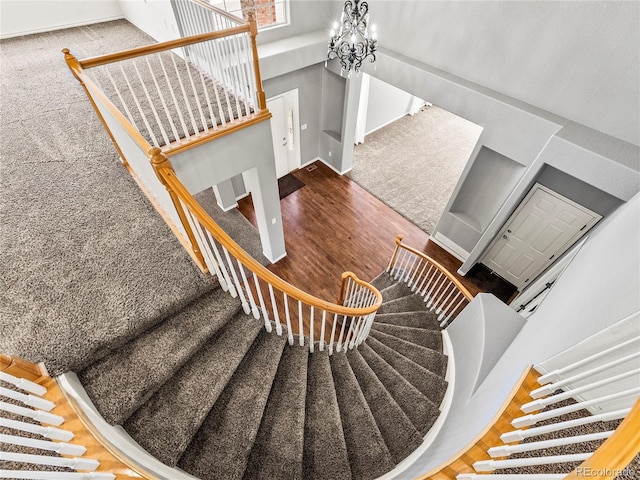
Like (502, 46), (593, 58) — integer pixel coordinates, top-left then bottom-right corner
(78, 288), (240, 425)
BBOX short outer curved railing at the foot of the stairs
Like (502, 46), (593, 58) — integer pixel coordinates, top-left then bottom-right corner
(387, 235), (473, 327)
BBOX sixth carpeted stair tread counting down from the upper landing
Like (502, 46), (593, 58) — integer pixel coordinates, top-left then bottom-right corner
(330, 353), (394, 480)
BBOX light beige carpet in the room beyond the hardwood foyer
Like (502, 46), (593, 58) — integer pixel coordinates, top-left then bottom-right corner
(349, 106), (482, 233)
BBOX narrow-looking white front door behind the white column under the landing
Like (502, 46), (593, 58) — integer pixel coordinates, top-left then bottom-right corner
(267, 89), (300, 178)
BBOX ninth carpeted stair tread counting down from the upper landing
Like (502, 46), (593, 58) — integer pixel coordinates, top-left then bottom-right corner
(367, 337), (447, 408)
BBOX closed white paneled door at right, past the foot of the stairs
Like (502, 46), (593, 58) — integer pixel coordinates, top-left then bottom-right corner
(482, 184), (602, 289)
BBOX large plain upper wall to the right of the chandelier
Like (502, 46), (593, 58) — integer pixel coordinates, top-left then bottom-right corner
(369, 0), (640, 145)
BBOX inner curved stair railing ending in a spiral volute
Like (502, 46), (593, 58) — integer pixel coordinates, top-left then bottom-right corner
(150, 152), (382, 354)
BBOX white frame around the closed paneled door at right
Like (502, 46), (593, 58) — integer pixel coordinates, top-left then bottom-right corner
(478, 182), (602, 291)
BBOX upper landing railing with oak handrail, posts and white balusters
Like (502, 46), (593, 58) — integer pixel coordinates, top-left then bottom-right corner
(62, 2), (271, 271)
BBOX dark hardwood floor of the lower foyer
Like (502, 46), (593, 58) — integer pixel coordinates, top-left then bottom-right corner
(238, 161), (508, 302)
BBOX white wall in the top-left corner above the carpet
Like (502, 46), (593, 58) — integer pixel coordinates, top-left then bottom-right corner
(0, 0), (122, 38)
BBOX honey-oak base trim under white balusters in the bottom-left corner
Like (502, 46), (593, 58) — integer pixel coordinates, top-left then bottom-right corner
(43, 378), (146, 480)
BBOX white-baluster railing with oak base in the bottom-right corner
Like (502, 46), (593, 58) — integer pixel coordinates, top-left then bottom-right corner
(412, 316), (640, 480)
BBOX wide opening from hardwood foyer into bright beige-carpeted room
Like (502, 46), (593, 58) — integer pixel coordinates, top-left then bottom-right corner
(349, 74), (482, 234)
